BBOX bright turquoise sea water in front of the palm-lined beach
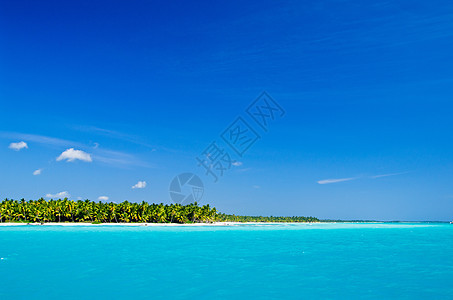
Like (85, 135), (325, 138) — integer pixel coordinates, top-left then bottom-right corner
(0, 224), (453, 299)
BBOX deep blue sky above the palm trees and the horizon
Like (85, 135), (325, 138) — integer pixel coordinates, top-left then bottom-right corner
(0, 0), (453, 220)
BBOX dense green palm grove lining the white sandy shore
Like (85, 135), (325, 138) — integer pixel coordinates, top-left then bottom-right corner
(0, 198), (319, 224)
